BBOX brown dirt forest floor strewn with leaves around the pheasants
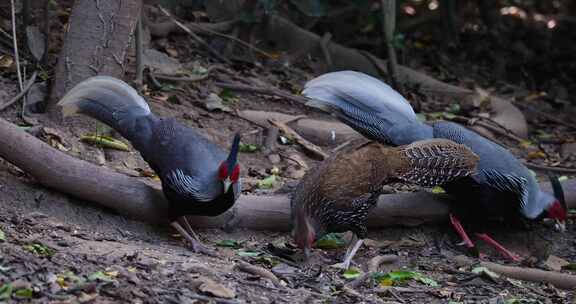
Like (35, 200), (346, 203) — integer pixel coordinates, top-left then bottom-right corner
(0, 10), (576, 304)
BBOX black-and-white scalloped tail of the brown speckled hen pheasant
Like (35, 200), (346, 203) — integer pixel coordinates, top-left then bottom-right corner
(395, 139), (480, 187)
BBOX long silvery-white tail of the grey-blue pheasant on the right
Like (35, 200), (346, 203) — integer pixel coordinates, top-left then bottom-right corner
(302, 71), (433, 145)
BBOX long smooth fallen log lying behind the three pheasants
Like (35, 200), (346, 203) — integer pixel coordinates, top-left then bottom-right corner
(0, 119), (576, 231)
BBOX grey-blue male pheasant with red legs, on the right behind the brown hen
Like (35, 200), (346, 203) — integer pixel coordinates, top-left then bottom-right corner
(303, 71), (566, 260)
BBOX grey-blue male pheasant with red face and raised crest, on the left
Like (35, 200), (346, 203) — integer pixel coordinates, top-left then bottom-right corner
(58, 76), (240, 253)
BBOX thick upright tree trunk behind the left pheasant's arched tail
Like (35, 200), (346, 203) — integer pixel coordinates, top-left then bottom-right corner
(48, 0), (142, 113)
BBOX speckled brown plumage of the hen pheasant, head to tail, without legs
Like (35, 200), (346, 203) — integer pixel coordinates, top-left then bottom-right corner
(291, 139), (478, 268)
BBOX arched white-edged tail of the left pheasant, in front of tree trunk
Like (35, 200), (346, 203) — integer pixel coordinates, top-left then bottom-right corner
(58, 76), (157, 149)
